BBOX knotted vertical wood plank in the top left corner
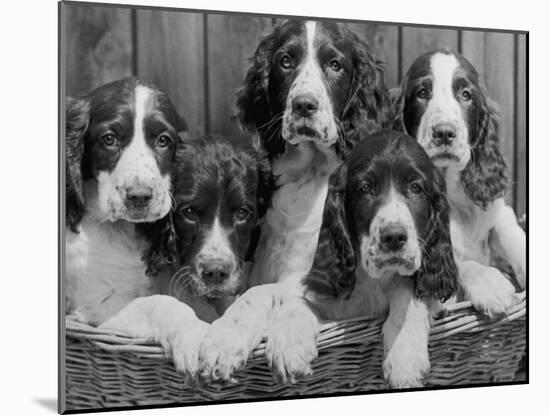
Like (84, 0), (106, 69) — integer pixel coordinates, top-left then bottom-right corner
(65, 4), (132, 95)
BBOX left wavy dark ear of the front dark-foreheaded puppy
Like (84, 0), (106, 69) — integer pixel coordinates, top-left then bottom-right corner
(304, 164), (356, 298)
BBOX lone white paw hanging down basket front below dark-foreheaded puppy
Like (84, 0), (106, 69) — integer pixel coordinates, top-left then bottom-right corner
(382, 350), (430, 389)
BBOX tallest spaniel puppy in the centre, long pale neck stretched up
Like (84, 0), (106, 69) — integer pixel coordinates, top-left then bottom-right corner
(201, 20), (390, 379)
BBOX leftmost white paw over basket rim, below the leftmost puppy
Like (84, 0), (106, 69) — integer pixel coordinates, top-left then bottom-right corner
(161, 322), (209, 379)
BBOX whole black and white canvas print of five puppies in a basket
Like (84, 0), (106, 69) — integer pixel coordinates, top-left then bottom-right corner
(58, 1), (528, 413)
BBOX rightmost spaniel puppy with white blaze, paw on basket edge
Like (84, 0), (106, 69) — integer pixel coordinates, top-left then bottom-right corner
(394, 50), (526, 316)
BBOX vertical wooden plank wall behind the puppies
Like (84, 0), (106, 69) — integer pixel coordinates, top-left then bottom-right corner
(62, 5), (527, 215)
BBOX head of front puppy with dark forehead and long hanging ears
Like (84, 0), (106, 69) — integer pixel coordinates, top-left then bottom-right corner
(304, 130), (458, 301)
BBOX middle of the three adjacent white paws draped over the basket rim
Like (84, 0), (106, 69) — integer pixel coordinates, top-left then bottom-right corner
(199, 320), (253, 381)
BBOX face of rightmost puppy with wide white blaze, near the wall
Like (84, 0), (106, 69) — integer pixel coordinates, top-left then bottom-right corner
(403, 51), (483, 171)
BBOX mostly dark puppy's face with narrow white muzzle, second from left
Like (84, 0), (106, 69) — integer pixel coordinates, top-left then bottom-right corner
(174, 139), (258, 298)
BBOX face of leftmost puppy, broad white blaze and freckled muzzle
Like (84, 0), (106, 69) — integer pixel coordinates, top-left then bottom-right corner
(82, 81), (182, 222)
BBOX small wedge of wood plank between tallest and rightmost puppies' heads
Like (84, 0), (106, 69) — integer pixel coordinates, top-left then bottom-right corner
(347, 23), (399, 88)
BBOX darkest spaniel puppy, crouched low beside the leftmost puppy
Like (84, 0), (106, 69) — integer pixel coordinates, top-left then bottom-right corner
(142, 136), (273, 322)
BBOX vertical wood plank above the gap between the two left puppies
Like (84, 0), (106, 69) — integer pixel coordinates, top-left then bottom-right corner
(136, 10), (205, 136)
